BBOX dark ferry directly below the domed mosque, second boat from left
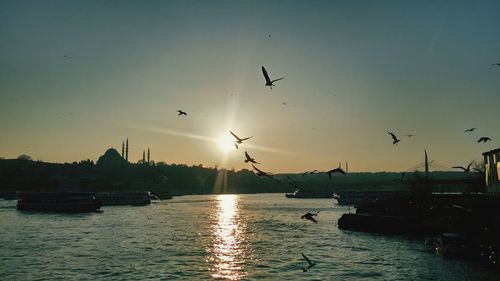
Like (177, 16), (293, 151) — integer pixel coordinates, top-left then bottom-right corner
(96, 191), (152, 206)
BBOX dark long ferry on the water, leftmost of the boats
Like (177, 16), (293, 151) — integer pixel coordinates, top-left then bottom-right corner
(17, 192), (102, 213)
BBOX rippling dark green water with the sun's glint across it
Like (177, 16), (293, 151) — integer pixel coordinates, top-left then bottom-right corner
(0, 194), (499, 280)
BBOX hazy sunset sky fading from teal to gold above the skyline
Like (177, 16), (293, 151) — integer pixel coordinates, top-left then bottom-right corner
(0, 0), (500, 173)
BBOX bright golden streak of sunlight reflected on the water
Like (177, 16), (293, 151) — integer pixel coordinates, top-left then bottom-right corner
(209, 194), (248, 280)
